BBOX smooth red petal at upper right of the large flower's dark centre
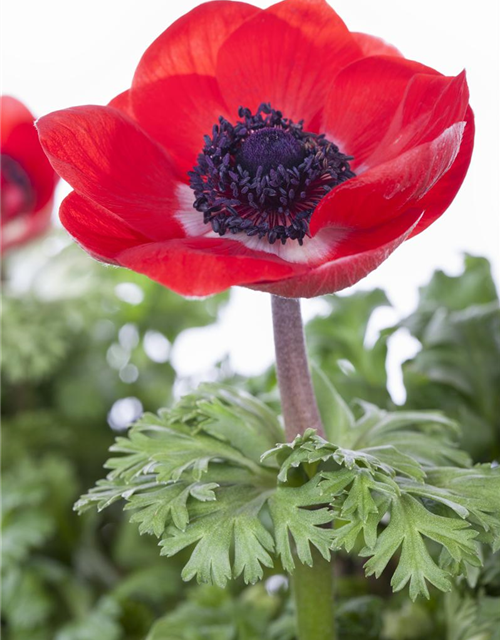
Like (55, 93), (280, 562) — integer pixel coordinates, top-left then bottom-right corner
(321, 56), (437, 170)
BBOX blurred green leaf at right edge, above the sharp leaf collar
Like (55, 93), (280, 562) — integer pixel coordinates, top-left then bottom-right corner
(402, 256), (500, 460)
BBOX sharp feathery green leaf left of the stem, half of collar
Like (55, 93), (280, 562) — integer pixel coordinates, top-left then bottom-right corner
(75, 385), (282, 586)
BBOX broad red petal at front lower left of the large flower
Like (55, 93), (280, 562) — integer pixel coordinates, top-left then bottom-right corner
(119, 238), (303, 297)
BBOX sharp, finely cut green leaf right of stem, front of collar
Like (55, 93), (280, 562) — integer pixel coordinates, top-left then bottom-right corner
(266, 420), (500, 599)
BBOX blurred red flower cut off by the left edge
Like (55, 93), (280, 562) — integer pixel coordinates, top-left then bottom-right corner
(0, 96), (58, 253)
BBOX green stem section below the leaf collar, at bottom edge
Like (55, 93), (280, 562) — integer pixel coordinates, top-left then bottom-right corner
(292, 549), (337, 640)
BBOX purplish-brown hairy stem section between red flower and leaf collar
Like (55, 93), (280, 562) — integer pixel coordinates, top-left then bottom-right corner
(272, 296), (324, 442)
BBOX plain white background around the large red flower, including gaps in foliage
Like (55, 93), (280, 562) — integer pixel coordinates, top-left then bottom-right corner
(0, 0), (500, 396)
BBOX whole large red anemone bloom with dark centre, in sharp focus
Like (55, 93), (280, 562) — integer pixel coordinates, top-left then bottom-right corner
(38, 0), (474, 297)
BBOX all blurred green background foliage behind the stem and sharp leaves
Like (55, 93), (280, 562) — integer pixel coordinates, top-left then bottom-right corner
(0, 241), (500, 640)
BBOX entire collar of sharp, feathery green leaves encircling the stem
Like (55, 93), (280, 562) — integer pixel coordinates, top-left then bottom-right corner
(76, 379), (500, 599)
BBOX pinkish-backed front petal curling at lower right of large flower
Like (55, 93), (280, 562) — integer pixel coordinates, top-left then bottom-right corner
(250, 211), (420, 298)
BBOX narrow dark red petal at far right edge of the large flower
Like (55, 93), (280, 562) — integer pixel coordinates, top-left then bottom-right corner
(412, 107), (474, 236)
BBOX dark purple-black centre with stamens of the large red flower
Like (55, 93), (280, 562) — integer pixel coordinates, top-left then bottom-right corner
(189, 104), (355, 244)
